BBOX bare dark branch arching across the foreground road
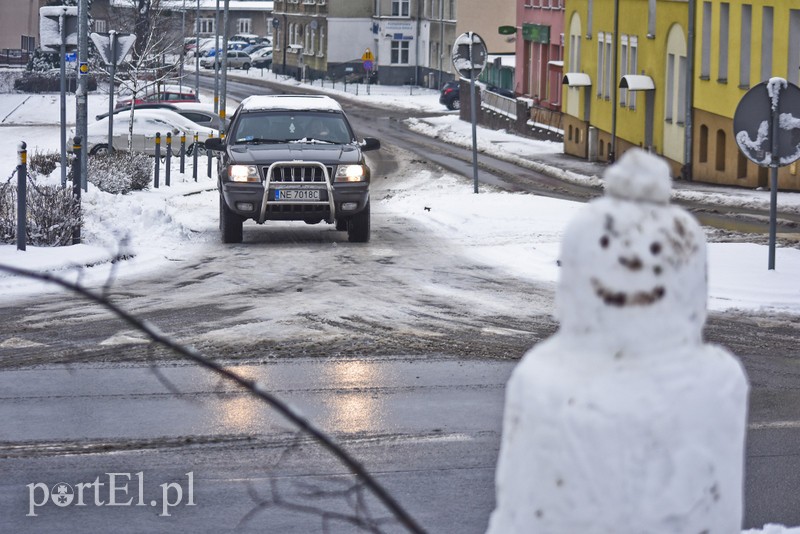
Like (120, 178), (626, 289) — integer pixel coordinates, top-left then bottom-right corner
(0, 264), (425, 534)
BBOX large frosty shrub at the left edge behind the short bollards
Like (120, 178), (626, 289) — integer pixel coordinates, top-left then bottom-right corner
(0, 179), (82, 247)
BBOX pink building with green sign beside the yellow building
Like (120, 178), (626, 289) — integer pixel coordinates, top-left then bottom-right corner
(514, 0), (565, 110)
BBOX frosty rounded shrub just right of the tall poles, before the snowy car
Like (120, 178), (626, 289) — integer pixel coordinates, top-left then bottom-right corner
(88, 151), (153, 195)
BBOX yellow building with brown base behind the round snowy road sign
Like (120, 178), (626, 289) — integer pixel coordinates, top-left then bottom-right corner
(692, 0), (800, 190)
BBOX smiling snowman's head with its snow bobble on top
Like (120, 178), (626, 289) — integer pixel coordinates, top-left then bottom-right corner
(556, 149), (707, 352)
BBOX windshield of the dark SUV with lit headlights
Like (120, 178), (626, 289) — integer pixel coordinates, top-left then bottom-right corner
(231, 111), (354, 144)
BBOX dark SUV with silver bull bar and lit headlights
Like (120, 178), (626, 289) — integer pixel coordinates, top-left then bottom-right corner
(205, 95), (381, 243)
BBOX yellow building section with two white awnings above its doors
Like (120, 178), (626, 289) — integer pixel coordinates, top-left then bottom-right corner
(563, 0), (688, 175)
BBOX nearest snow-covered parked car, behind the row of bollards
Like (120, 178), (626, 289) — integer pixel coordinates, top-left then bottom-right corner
(76, 108), (219, 156)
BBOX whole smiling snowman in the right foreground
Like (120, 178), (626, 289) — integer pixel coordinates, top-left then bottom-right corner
(488, 149), (748, 534)
